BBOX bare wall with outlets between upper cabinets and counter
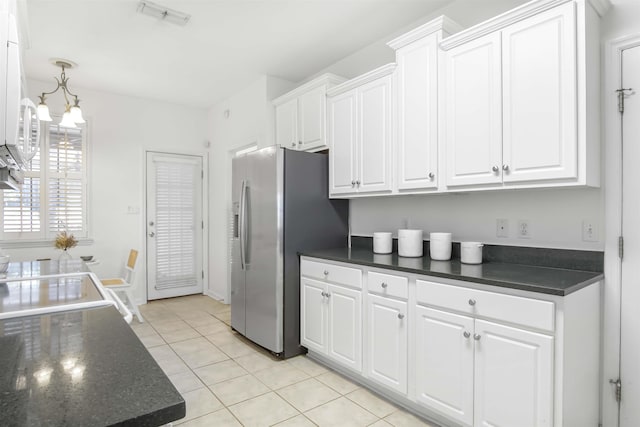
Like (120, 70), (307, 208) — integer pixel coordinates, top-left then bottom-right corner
(351, 188), (604, 250)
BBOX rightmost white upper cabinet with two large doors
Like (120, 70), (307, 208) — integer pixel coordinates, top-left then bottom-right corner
(440, 0), (602, 189)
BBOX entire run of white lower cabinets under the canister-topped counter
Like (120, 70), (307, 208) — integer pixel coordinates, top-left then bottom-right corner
(301, 257), (600, 427)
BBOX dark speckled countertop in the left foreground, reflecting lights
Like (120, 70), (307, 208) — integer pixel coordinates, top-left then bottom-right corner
(0, 307), (185, 427)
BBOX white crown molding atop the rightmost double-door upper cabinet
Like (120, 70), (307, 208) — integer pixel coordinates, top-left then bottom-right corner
(440, 0), (568, 50)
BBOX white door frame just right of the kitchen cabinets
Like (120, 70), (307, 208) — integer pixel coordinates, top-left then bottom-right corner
(601, 33), (640, 426)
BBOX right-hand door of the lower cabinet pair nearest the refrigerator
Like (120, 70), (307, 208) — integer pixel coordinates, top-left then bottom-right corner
(327, 285), (362, 372)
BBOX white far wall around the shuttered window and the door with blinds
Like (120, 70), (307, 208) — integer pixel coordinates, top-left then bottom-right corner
(8, 76), (207, 301)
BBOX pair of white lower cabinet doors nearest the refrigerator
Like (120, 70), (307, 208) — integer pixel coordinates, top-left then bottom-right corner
(300, 277), (362, 372)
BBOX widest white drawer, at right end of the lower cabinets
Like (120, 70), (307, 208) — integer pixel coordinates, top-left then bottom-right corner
(416, 280), (554, 332)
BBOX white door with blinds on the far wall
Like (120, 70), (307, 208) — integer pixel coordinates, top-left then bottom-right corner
(146, 152), (204, 300)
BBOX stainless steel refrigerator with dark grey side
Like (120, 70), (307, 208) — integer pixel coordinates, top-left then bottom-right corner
(231, 146), (349, 358)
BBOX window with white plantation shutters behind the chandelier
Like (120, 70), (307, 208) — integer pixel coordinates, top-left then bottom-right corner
(0, 122), (88, 241)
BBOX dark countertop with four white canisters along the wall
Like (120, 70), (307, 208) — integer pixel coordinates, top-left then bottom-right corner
(300, 248), (604, 296)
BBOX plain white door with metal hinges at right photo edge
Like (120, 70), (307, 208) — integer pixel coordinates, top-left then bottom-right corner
(620, 46), (640, 427)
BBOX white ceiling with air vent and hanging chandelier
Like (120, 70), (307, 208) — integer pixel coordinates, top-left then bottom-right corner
(25, 0), (452, 107)
